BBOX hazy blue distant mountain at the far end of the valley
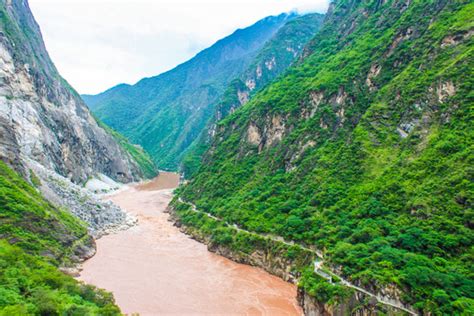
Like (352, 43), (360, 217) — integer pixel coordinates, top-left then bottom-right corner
(83, 14), (324, 169)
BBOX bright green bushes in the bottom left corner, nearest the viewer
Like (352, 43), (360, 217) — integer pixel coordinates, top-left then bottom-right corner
(0, 240), (120, 316)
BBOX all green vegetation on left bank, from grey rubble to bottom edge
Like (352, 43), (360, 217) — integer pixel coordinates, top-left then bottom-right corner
(0, 162), (120, 315)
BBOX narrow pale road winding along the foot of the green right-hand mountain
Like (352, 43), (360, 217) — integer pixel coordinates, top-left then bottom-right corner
(178, 197), (418, 315)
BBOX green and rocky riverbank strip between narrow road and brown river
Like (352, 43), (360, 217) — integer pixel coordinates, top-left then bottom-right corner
(169, 198), (416, 315)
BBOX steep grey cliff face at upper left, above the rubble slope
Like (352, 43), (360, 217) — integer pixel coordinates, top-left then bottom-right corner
(0, 0), (142, 183)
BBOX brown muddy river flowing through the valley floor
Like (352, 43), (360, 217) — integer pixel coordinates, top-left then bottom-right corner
(79, 173), (302, 315)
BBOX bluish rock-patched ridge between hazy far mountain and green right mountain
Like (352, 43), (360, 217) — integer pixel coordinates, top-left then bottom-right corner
(180, 13), (324, 176)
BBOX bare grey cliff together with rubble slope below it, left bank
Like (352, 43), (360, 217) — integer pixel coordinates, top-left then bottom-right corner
(0, 0), (142, 244)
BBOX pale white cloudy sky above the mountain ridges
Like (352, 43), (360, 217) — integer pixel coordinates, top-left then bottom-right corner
(29, 0), (329, 94)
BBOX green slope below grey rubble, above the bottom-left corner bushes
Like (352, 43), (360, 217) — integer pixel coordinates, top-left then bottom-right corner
(0, 162), (90, 264)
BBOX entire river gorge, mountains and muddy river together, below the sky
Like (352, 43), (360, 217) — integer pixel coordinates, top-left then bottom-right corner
(0, 0), (474, 316)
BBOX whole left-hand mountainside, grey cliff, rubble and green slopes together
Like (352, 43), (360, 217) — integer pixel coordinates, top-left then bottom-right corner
(0, 0), (154, 315)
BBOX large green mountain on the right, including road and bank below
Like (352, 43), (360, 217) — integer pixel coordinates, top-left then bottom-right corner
(173, 0), (474, 315)
